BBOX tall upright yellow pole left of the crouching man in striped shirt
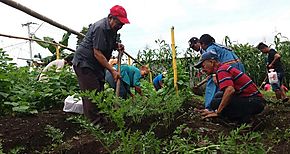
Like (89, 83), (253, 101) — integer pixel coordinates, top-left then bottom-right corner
(171, 26), (178, 95)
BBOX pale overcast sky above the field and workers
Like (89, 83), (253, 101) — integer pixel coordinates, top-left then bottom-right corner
(0, 0), (290, 65)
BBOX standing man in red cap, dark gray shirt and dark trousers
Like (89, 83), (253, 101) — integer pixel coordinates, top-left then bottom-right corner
(73, 5), (129, 124)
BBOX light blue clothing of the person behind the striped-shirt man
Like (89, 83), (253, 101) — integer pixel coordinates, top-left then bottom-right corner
(204, 43), (245, 109)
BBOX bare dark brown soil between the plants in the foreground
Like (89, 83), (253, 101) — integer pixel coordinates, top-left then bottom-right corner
(0, 101), (290, 154)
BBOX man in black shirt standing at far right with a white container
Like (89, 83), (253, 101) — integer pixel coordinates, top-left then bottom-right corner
(257, 42), (289, 102)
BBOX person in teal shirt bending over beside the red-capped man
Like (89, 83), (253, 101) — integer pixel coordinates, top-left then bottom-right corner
(105, 65), (149, 99)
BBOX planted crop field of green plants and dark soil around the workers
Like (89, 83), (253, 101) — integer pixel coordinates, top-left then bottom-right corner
(0, 34), (290, 154)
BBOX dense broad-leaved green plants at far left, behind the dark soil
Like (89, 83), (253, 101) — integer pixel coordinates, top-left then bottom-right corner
(0, 49), (78, 115)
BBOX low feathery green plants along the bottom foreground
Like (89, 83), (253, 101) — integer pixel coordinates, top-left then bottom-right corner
(70, 112), (270, 153)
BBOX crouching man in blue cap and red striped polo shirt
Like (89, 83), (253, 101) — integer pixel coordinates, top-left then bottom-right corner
(196, 52), (266, 123)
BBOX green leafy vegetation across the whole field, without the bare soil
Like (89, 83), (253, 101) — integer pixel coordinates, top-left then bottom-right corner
(0, 34), (290, 153)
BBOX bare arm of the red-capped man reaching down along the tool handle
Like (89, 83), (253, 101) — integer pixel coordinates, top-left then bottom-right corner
(94, 48), (120, 80)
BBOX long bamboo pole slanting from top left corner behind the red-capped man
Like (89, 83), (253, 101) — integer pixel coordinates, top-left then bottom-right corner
(0, 0), (142, 65)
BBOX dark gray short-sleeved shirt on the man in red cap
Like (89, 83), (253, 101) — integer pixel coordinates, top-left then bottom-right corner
(73, 18), (117, 78)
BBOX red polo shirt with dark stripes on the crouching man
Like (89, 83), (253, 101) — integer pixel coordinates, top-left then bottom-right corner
(217, 64), (262, 97)
